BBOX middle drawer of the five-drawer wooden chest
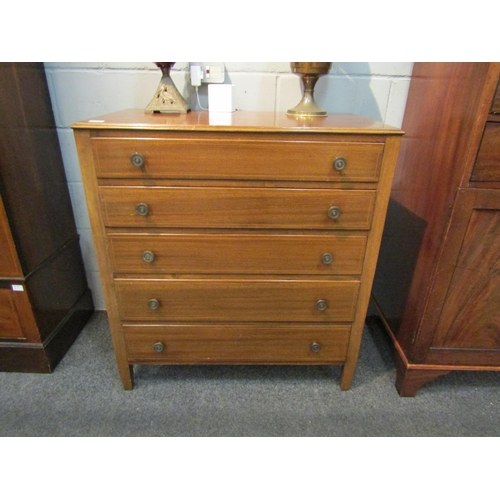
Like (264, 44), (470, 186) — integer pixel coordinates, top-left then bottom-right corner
(108, 234), (366, 275)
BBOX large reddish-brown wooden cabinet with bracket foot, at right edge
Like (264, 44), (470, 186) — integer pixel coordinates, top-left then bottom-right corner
(373, 63), (500, 396)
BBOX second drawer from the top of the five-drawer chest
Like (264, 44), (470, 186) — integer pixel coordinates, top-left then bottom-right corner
(100, 187), (375, 230)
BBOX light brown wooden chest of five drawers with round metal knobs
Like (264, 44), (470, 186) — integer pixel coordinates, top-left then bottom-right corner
(73, 110), (402, 389)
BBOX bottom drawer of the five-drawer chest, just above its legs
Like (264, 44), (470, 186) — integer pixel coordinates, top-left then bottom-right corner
(123, 324), (351, 364)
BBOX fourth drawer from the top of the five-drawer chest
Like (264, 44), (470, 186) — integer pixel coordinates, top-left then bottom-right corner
(115, 279), (359, 322)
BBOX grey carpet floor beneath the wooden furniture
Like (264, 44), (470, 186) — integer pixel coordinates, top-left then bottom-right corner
(0, 312), (500, 437)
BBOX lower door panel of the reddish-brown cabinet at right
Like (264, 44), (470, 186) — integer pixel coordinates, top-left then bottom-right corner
(433, 190), (500, 350)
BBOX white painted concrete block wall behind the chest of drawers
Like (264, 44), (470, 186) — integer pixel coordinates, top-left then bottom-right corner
(45, 62), (413, 310)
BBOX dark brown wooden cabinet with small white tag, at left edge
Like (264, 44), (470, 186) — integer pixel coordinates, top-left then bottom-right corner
(0, 63), (93, 372)
